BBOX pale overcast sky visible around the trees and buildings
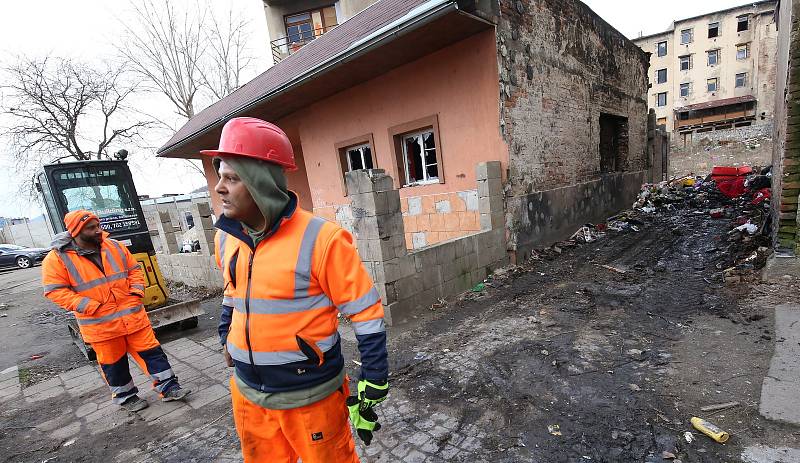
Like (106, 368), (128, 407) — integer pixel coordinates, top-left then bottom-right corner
(0, 0), (760, 217)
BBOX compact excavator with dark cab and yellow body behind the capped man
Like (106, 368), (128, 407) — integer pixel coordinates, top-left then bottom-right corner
(34, 150), (204, 360)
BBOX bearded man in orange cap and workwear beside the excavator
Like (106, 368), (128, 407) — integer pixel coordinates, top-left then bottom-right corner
(42, 210), (190, 412)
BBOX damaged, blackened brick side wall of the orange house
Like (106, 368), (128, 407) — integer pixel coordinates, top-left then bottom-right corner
(484, 0), (649, 253)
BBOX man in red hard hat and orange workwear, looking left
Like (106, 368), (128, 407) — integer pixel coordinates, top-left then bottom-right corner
(203, 117), (389, 463)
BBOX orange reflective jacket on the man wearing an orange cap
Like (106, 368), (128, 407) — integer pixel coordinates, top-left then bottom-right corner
(42, 233), (150, 342)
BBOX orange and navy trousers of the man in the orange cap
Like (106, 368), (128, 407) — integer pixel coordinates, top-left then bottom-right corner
(91, 327), (178, 404)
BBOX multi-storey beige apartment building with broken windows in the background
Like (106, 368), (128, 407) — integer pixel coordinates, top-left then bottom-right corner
(633, 0), (777, 143)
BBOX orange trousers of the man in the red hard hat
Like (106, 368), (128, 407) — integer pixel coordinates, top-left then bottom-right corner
(231, 378), (359, 463)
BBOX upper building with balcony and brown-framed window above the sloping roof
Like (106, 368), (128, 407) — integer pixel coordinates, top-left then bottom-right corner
(263, 0), (378, 64)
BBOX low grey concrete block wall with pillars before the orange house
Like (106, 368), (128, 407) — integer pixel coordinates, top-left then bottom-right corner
(346, 161), (508, 324)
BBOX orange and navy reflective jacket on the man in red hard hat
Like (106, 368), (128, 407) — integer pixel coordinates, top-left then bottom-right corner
(215, 193), (388, 392)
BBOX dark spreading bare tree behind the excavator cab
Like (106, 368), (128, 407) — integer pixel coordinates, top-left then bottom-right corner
(0, 57), (151, 167)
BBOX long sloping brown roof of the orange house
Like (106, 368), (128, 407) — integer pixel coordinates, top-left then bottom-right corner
(158, 0), (444, 156)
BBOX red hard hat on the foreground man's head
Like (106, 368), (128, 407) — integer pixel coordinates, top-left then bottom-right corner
(200, 117), (297, 170)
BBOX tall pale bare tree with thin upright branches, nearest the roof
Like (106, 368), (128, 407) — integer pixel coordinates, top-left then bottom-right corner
(117, 0), (252, 119)
